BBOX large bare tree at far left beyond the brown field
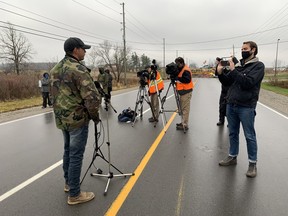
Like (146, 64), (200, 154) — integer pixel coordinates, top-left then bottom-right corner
(0, 23), (32, 75)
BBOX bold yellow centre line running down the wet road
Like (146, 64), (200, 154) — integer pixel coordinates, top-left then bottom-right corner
(105, 112), (177, 216)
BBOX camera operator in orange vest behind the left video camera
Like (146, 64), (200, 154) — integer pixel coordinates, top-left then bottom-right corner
(146, 65), (164, 122)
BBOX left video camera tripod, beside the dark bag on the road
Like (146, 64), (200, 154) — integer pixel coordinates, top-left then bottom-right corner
(132, 82), (157, 127)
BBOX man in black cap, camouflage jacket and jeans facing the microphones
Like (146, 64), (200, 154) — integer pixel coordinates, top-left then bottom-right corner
(51, 37), (100, 205)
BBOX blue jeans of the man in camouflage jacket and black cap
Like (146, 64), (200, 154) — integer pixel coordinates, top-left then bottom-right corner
(62, 125), (88, 197)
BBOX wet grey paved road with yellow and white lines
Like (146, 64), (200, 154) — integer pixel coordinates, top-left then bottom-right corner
(0, 79), (288, 216)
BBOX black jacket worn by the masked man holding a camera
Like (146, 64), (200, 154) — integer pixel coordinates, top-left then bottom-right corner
(218, 58), (265, 108)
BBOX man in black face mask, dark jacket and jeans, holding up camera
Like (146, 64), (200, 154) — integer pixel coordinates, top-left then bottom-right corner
(217, 41), (265, 178)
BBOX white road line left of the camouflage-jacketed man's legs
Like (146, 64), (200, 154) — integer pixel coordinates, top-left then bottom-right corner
(0, 160), (63, 202)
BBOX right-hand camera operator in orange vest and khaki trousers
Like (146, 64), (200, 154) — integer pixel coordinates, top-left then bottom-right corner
(175, 57), (194, 130)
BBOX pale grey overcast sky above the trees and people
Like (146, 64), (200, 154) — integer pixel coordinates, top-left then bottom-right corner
(0, 0), (288, 67)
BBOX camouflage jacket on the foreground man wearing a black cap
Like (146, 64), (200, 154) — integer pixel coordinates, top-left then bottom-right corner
(51, 56), (100, 130)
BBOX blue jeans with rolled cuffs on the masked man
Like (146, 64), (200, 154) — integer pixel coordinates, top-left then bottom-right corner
(226, 104), (257, 163)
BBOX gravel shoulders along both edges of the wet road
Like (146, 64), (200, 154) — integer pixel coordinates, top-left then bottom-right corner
(0, 88), (288, 123)
